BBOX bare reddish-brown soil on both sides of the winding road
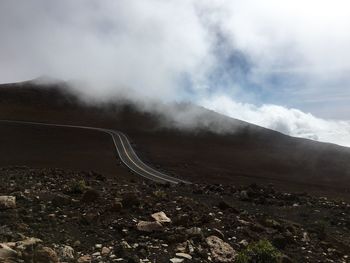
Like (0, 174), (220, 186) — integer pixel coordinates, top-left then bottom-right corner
(0, 80), (350, 199)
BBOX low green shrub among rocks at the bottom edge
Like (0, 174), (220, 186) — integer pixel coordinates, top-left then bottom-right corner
(236, 240), (281, 263)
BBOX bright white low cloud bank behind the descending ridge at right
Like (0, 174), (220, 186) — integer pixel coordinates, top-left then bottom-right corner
(199, 95), (350, 147)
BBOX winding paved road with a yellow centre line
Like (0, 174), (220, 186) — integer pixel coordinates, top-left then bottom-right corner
(0, 120), (190, 184)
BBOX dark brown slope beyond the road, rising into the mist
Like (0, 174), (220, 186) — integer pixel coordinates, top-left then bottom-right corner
(0, 82), (350, 200)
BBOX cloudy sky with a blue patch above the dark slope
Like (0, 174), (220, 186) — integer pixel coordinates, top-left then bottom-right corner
(0, 0), (350, 146)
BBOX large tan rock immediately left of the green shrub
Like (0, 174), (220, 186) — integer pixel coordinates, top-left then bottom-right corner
(206, 236), (237, 262)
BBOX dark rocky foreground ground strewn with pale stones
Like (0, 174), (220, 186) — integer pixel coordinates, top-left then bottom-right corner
(0, 167), (350, 263)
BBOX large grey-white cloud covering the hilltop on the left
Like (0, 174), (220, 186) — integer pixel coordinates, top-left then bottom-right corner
(0, 0), (210, 98)
